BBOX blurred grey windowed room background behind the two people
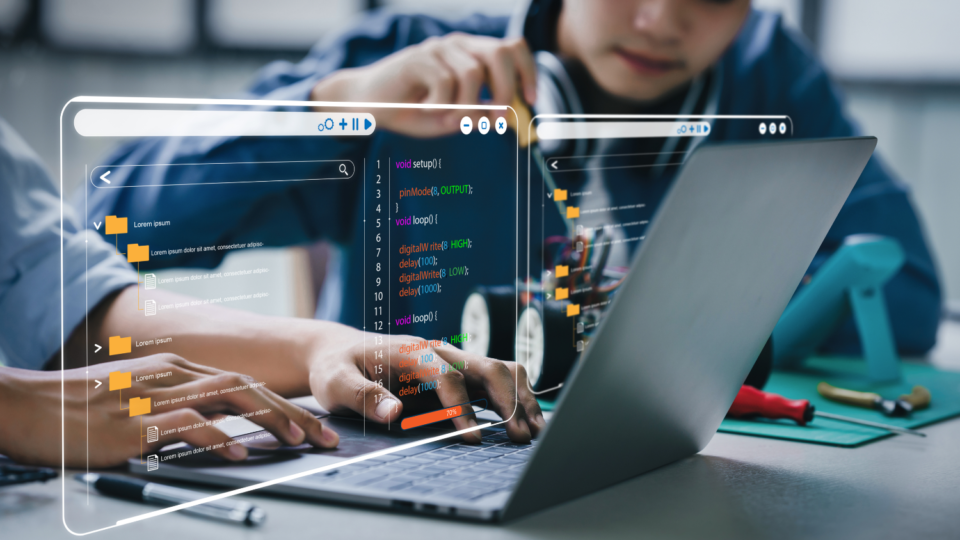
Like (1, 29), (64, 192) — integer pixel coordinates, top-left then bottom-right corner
(0, 0), (960, 320)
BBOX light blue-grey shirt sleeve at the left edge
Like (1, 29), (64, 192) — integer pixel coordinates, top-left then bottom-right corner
(0, 119), (137, 369)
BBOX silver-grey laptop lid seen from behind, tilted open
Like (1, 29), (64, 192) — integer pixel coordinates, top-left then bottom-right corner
(503, 137), (877, 519)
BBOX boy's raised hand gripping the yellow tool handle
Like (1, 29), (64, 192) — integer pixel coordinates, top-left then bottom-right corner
(310, 33), (537, 137)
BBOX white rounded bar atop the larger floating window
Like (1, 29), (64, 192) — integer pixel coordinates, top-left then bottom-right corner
(73, 109), (377, 137)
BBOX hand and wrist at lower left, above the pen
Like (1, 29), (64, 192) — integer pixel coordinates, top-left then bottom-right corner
(0, 354), (339, 468)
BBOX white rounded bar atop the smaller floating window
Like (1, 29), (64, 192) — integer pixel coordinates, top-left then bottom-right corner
(537, 122), (712, 140)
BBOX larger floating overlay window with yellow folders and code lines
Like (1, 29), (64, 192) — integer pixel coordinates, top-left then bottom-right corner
(62, 98), (516, 533)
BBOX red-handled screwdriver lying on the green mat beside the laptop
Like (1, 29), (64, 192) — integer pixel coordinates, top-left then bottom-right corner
(728, 385), (927, 437)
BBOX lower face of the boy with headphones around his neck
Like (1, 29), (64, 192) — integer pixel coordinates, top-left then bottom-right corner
(557, 0), (750, 101)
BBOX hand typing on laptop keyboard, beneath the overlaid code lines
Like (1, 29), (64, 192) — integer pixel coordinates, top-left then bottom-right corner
(310, 328), (546, 443)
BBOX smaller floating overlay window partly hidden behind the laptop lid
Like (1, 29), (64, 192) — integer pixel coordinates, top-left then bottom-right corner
(516, 114), (793, 392)
